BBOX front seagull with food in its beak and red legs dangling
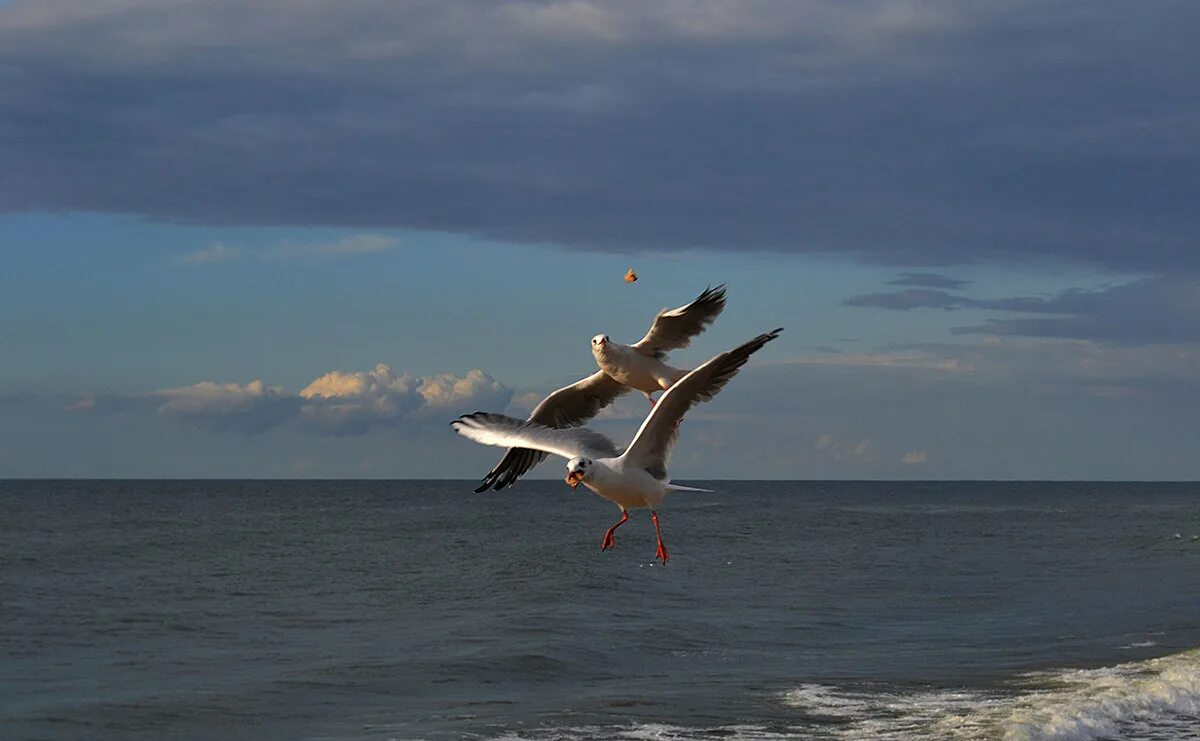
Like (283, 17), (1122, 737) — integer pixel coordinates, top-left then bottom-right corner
(450, 329), (782, 565)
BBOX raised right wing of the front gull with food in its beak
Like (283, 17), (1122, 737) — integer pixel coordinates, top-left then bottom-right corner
(625, 329), (784, 478)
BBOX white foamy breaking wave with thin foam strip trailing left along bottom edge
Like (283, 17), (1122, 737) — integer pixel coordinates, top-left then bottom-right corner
(480, 649), (1200, 741)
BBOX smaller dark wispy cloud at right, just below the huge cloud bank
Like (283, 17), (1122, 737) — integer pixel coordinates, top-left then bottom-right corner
(844, 275), (1200, 344)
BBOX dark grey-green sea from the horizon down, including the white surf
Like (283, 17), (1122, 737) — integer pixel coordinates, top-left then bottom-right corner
(0, 481), (1200, 740)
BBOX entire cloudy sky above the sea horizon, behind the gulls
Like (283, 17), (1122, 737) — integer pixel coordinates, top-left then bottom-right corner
(0, 0), (1200, 481)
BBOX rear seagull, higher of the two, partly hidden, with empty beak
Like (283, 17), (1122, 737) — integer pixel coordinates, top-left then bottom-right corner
(475, 285), (725, 493)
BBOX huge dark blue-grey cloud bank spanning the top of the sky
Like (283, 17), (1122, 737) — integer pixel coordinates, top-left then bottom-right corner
(0, 0), (1200, 268)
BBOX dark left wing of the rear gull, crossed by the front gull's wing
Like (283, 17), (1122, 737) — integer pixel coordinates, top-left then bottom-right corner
(475, 371), (629, 492)
